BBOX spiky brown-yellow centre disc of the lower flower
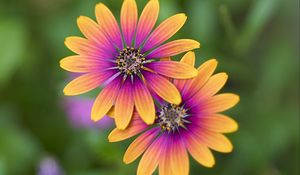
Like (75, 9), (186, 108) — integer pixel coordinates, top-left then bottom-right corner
(157, 104), (190, 132)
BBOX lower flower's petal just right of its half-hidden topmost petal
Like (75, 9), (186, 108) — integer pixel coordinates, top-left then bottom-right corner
(182, 59), (218, 99)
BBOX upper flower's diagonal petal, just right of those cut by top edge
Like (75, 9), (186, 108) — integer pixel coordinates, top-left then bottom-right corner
(143, 13), (187, 51)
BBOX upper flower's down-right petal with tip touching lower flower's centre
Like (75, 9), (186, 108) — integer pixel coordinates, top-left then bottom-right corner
(144, 72), (181, 104)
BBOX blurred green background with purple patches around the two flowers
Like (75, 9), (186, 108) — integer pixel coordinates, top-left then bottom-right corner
(0, 0), (299, 175)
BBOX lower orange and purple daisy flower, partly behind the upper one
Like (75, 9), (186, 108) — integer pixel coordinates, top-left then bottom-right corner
(108, 52), (239, 175)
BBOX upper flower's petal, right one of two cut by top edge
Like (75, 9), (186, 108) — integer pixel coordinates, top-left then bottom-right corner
(136, 0), (159, 47)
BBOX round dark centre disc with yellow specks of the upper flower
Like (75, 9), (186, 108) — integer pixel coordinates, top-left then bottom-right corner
(116, 47), (145, 75)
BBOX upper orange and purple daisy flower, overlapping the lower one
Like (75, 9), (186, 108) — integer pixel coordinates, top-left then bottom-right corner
(60, 0), (200, 129)
